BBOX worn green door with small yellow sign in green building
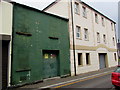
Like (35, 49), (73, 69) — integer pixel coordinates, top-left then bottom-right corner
(43, 51), (58, 78)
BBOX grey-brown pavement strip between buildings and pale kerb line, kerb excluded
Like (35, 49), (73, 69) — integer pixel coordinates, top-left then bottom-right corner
(14, 67), (116, 89)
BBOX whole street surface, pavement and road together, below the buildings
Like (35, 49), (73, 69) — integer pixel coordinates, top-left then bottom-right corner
(13, 67), (116, 90)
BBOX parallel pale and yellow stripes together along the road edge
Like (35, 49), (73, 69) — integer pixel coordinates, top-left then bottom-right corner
(39, 70), (113, 89)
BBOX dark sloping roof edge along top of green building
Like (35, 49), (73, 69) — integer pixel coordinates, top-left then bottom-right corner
(3, 0), (69, 21)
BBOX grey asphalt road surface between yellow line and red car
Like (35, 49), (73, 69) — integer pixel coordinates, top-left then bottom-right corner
(56, 74), (115, 90)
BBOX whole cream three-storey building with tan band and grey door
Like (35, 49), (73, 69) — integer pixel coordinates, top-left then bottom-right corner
(43, 0), (118, 75)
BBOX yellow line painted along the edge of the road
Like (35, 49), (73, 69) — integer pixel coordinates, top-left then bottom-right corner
(53, 72), (111, 88)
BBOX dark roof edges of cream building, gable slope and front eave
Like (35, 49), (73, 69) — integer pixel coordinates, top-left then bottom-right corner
(42, 0), (116, 24)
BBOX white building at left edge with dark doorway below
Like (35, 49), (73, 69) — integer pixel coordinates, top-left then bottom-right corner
(0, 1), (13, 89)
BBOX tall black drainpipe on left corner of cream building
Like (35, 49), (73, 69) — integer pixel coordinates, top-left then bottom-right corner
(70, 0), (76, 76)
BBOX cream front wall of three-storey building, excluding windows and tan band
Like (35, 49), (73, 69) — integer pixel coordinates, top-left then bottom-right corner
(71, 0), (117, 75)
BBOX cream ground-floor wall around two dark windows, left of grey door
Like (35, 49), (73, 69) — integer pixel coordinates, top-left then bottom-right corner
(76, 50), (99, 74)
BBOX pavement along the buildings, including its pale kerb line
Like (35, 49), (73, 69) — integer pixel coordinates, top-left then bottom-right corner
(14, 67), (116, 90)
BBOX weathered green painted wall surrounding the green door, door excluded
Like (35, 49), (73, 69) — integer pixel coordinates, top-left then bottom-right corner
(11, 4), (70, 85)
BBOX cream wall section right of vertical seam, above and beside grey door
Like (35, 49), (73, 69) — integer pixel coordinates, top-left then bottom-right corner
(93, 11), (118, 67)
